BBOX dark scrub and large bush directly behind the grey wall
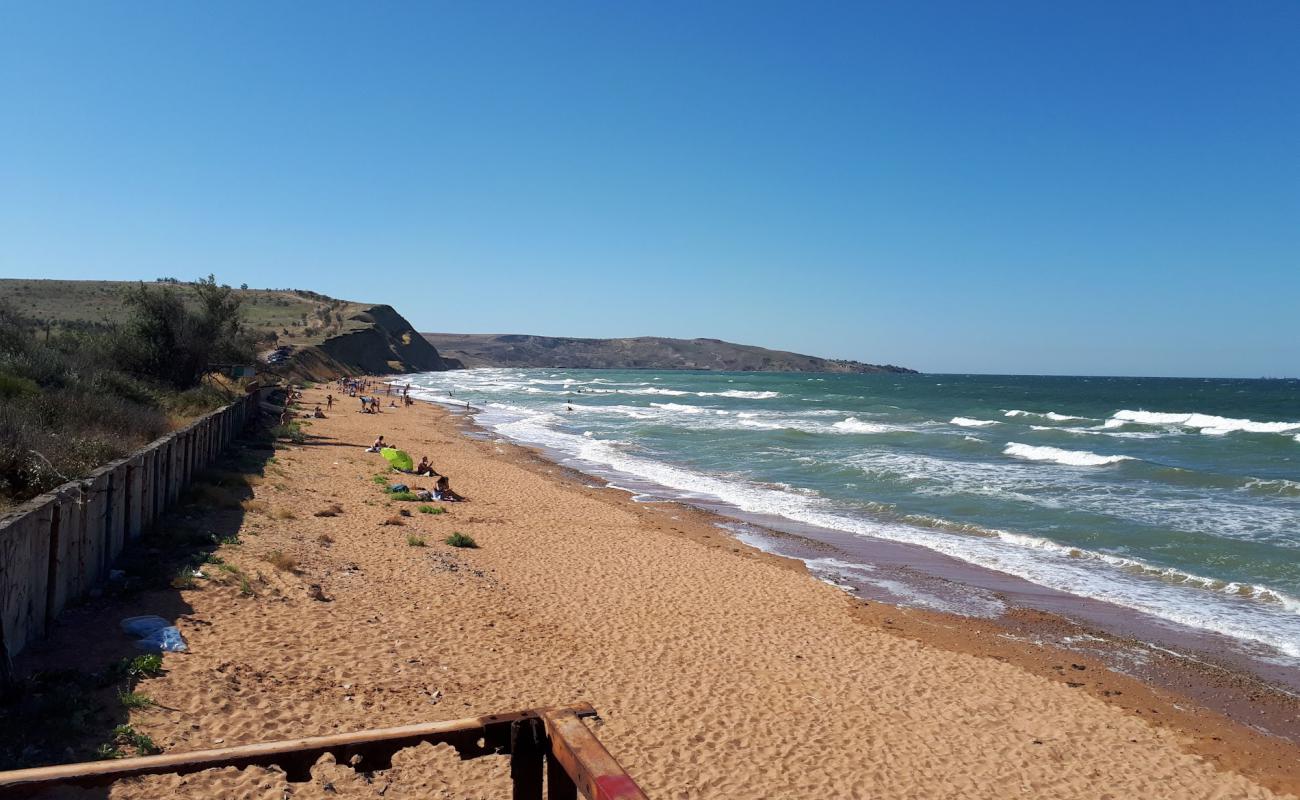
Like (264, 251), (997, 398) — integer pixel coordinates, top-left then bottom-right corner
(0, 276), (256, 507)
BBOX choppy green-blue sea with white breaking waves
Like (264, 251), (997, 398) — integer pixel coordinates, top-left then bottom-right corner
(410, 368), (1300, 669)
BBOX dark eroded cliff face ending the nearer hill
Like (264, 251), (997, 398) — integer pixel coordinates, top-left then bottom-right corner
(289, 306), (460, 380)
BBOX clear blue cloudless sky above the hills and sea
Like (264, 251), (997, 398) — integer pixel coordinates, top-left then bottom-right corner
(0, 0), (1300, 376)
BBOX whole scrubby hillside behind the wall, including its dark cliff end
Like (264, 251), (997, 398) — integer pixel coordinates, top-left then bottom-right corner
(0, 276), (460, 507)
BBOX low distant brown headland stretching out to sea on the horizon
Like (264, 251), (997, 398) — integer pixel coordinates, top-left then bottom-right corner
(424, 333), (915, 373)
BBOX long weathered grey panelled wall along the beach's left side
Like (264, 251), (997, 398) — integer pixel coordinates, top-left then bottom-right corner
(0, 392), (260, 679)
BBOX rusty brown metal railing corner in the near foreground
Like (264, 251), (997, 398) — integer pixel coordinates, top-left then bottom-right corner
(0, 702), (646, 800)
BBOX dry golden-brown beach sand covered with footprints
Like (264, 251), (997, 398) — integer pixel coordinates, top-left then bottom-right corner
(22, 390), (1296, 799)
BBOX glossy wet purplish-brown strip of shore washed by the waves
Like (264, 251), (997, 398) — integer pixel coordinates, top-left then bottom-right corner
(419, 397), (1300, 712)
